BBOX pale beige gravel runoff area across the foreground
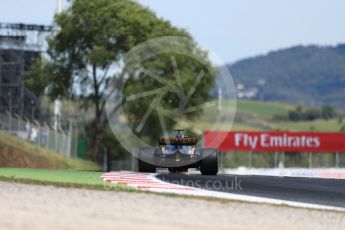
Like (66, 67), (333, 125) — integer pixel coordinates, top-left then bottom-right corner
(0, 182), (345, 230)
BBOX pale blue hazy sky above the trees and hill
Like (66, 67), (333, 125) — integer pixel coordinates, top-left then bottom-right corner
(0, 0), (345, 62)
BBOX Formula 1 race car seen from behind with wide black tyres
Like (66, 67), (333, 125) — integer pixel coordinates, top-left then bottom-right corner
(138, 129), (218, 175)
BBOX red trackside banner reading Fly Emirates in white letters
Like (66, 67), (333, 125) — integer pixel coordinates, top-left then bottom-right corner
(204, 131), (345, 153)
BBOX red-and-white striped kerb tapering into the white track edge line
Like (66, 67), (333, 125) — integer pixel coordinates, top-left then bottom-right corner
(101, 171), (345, 212)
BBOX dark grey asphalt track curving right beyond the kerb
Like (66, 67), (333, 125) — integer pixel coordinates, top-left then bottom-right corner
(157, 174), (345, 208)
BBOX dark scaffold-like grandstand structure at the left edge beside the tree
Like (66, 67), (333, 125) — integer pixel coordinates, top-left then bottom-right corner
(0, 23), (53, 120)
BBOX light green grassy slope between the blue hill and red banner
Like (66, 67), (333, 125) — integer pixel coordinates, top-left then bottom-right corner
(189, 99), (345, 132)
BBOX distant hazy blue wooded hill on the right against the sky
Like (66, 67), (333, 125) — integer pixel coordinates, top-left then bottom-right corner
(228, 44), (345, 108)
